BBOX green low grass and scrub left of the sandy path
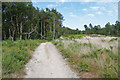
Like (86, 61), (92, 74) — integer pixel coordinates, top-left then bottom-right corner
(2, 40), (45, 78)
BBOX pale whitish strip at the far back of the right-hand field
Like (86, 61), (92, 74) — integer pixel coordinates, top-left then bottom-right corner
(62, 36), (118, 53)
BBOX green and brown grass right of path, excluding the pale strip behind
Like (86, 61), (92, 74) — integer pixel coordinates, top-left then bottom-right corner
(53, 39), (118, 78)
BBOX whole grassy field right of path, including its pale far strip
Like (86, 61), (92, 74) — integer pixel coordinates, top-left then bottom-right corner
(56, 36), (118, 78)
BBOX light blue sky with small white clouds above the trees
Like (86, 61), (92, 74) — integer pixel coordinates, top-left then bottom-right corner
(33, 2), (118, 30)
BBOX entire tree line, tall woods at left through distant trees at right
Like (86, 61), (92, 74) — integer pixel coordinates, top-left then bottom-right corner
(2, 2), (120, 40)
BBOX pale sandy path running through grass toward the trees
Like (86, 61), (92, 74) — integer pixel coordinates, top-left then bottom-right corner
(25, 42), (78, 78)
